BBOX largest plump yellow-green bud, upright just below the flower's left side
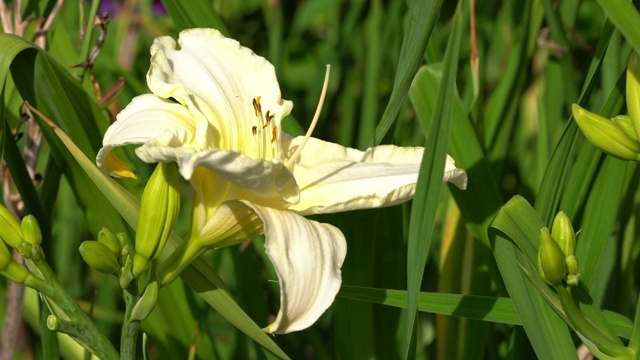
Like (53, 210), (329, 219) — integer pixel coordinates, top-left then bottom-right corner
(132, 163), (180, 278)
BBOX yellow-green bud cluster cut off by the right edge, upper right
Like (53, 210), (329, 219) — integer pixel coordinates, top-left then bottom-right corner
(572, 52), (640, 161)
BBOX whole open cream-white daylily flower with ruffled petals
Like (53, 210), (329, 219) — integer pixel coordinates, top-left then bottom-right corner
(97, 29), (466, 333)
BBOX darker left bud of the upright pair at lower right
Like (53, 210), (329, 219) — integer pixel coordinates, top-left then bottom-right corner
(538, 227), (567, 286)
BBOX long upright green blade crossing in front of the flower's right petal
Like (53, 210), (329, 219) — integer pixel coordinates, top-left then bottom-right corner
(404, 7), (462, 358)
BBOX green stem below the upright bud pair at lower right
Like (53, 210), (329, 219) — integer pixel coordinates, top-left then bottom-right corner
(555, 285), (635, 359)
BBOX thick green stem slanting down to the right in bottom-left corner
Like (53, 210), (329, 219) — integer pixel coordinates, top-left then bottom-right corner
(27, 259), (119, 360)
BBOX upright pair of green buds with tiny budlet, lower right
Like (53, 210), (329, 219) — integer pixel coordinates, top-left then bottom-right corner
(538, 211), (579, 286)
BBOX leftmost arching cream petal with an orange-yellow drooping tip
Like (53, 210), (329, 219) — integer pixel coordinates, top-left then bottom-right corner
(96, 95), (196, 175)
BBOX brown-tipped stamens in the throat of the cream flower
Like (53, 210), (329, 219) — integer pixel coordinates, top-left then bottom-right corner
(251, 96), (280, 160)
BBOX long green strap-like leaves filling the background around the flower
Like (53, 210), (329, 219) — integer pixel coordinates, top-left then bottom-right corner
(0, 0), (640, 359)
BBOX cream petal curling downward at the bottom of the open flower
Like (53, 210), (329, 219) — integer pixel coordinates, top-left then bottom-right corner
(245, 202), (347, 334)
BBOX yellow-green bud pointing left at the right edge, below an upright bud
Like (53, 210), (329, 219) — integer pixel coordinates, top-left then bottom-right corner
(571, 104), (640, 161)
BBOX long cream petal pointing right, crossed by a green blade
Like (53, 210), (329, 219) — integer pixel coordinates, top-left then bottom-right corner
(282, 135), (467, 215)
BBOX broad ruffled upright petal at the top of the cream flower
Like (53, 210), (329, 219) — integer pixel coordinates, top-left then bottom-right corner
(147, 29), (293, 157)
